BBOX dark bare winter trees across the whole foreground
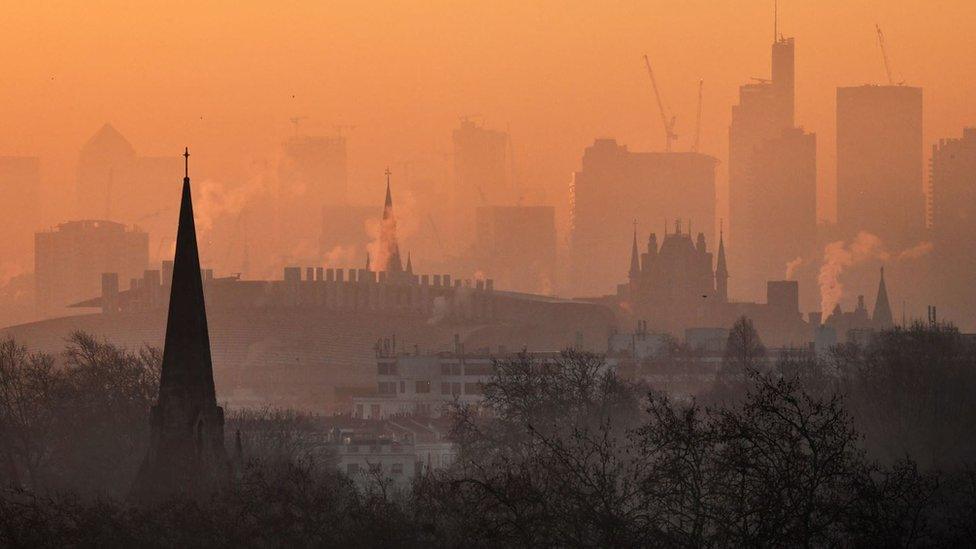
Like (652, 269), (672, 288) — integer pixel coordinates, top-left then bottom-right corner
(0, 320), (976, 547)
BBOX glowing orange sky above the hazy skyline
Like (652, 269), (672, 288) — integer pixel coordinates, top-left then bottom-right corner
(0, 0), (976, 233)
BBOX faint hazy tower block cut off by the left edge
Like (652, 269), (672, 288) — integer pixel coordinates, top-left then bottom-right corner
(0, 156), (41, 268)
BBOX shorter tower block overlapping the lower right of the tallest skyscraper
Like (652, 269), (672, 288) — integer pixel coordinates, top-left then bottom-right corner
(736, 128), (817, 303)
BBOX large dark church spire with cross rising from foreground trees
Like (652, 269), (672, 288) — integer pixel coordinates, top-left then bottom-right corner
(132, 150), (230, 501)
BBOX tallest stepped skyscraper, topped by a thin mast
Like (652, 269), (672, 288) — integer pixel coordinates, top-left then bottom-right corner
(729, 37), (817, 299)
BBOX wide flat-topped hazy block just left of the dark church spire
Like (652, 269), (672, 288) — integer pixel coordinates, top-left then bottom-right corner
(34, 220), (149, 316)
